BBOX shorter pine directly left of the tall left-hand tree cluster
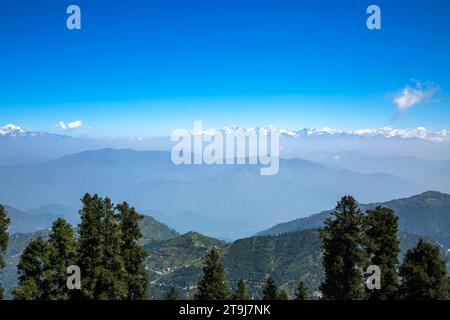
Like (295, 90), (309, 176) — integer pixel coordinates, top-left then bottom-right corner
(48, 218), (77, 300)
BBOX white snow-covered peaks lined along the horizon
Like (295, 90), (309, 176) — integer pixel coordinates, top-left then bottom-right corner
(0, 124), (450, 142)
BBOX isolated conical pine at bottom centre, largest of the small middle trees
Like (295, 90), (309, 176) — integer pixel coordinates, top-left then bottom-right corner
(195, 248), (229, 300)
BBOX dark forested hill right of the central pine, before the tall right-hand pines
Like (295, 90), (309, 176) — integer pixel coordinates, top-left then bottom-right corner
(223, 230), (323, 298)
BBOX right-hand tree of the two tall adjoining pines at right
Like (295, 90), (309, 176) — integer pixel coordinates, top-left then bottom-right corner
(366, 207), (400, 300)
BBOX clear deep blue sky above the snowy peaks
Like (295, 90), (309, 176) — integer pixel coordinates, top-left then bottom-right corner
(0, 0), (450, 136)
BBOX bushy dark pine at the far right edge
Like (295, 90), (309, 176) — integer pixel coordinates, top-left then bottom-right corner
(399, 240), (449, 300)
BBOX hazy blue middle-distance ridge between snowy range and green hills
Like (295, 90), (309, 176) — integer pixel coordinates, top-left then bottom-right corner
(0, 149), (425, 239)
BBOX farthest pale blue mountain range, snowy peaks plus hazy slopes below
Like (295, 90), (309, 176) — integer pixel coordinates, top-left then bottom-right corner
(0, 124), (450, 165)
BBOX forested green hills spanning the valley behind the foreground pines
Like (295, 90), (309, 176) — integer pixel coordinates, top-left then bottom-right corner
(0, 192), (450, 299)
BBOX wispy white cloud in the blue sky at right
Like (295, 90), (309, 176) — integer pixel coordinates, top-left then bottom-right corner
(393, 82), (438, 112)
